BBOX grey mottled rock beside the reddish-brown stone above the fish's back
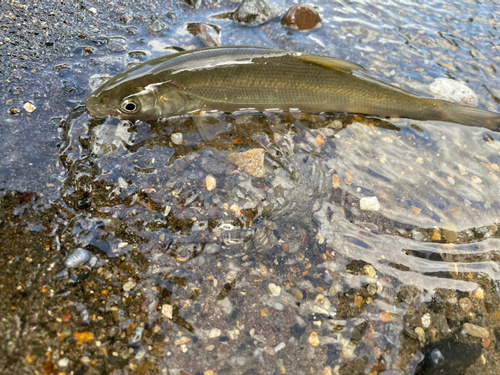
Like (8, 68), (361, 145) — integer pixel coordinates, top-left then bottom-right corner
(233, 0), (285, 26)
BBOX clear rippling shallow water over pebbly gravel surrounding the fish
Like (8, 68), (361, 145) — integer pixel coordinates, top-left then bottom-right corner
(0, 1), (500, 374)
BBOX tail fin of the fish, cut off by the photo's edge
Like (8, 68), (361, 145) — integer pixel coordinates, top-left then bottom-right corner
(440, 101), (500, 131)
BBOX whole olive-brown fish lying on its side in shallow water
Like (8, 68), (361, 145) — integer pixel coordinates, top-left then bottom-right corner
(85, 46), (500, 131)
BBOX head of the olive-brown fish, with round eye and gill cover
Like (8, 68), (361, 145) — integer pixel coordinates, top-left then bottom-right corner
(85, 79), (190, 121)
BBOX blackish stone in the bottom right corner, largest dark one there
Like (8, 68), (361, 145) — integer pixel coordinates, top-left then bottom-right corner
(415, 339), (482, 375)
